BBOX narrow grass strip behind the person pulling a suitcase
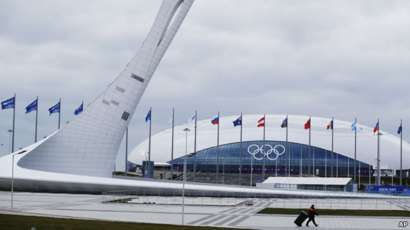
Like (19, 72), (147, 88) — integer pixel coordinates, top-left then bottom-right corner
(259, 208), (410, 217)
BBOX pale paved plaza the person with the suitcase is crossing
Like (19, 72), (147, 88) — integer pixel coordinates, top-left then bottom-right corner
(0, 192), (410, 229)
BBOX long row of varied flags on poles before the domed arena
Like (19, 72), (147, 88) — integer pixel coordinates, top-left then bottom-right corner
(145, 108), (403, 185)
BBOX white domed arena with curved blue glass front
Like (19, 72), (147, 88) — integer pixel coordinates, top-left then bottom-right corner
(129, 114), (410, 184)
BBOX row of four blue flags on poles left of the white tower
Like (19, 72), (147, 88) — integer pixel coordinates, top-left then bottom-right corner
(1, 94), (84, 152)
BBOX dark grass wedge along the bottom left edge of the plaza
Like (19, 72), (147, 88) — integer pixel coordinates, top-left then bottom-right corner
(0, 214), (243, 230)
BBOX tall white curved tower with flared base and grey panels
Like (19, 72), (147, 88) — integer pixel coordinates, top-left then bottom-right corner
(18, 0), (193, 176)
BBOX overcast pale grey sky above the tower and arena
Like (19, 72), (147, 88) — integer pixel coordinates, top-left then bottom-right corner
(0, 0), (410, 168)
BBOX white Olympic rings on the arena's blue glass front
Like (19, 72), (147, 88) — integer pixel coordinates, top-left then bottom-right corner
(248, 144), (286, 161)
